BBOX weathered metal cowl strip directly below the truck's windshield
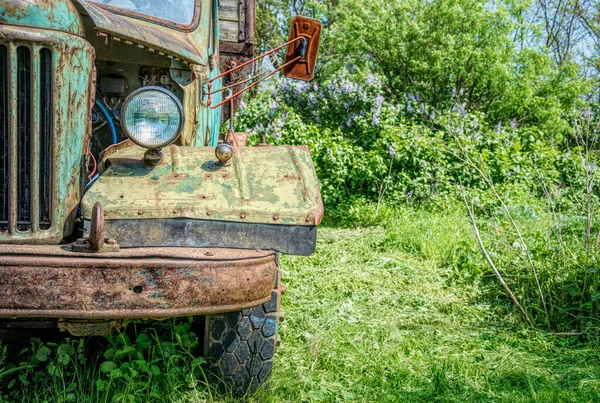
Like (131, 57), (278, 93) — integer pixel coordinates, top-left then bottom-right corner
(74, 0), (208, 66)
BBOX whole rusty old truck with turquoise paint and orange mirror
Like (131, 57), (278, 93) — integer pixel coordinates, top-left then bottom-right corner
(0, 0), (323, 393)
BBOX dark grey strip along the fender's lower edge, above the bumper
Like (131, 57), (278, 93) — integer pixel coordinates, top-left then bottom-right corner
(85, 218), (317, 256)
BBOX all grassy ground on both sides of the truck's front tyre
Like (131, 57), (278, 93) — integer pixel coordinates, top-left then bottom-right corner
(0, 208), (600, 402)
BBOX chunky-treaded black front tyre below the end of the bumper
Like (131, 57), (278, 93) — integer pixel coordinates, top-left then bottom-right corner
(204, 271), (282, 396)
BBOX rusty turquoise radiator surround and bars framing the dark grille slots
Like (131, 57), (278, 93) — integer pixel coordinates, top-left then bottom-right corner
(0, 25), (94, 243)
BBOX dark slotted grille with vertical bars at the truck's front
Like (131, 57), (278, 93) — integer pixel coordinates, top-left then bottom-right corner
(0, 45), (54, 233)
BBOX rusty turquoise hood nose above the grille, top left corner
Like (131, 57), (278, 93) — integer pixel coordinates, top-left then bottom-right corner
(0, 0), (83, 36)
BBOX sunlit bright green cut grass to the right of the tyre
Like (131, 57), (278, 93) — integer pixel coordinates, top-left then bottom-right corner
(272, 210), (600, 402)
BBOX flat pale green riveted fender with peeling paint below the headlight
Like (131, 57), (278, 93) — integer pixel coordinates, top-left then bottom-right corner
(82, 143), (323, 224)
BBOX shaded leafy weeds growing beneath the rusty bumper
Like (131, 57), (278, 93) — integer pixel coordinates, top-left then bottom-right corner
(0, 320), (205, 402)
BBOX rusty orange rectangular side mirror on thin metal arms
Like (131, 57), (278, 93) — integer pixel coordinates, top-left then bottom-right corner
(283, 15), (322, 81)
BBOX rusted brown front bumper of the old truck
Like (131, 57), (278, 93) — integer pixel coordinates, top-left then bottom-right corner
(0, 245), (276, 319)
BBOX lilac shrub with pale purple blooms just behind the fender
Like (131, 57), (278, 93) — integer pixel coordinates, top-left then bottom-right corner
(236, 70), (564, 205)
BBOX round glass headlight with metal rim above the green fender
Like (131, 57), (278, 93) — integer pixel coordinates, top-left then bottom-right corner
(121, 87), (184, 149)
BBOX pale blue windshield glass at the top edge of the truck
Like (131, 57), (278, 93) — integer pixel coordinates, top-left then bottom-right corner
(91, 0), (196, 25)
